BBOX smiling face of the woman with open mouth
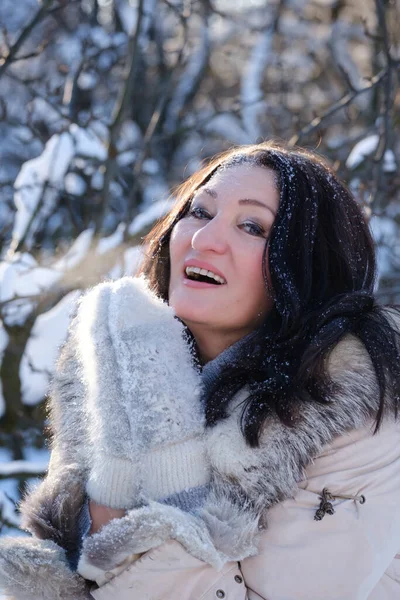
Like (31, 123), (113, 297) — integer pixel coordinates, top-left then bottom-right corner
(169, 164), (279, 352)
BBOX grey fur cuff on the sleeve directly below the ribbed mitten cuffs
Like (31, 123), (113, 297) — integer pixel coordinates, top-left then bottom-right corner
(77, 494), (259, 571)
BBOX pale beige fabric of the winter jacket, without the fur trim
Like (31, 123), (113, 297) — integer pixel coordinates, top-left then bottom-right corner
(91, 422), (400, 600)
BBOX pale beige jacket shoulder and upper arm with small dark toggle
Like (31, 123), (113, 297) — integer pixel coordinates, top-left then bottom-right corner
(241, 421), (400, 600)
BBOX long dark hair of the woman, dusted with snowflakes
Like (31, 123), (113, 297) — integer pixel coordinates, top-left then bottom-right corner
(141, 142), (400, 445)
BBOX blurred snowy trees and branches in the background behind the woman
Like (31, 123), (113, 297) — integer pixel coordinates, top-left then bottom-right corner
(0, 0), (400, 552)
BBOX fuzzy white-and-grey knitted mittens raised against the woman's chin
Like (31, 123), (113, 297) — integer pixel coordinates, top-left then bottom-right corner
(76, 277), (210, 509)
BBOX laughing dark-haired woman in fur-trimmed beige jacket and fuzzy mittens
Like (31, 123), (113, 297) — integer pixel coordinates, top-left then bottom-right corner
(0, 143), (400, 600)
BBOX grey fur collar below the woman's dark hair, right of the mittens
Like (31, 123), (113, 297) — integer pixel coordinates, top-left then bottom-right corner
(206, 336), (379, 514)
